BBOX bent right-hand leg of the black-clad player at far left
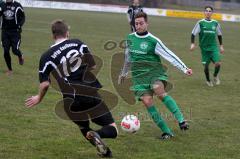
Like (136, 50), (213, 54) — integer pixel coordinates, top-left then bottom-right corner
(11, 31), (24, 65)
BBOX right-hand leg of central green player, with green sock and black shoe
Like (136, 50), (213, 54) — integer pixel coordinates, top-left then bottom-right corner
(153, 80), (189, 130)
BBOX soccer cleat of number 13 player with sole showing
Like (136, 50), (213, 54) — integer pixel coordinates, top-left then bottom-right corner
(87, 131), (112, 158)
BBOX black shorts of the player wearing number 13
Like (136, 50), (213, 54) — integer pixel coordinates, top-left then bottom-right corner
(64, 93), (114, 127)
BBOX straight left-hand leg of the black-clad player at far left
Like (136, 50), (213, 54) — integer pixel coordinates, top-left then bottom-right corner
(2, 31), (12, 75)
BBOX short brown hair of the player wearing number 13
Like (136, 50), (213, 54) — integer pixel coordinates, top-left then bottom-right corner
(52, 20), (69, 37)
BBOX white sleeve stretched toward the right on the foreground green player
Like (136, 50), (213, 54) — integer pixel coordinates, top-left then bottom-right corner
(155, 41), (188, 73)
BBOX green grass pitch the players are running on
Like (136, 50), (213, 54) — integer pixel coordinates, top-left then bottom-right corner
(0, 9), (240, 159)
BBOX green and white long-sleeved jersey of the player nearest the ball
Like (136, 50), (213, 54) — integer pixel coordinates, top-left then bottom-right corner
(122, 32), (188, 76)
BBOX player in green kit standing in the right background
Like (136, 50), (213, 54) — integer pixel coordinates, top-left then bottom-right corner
(190, 6), (224, 87)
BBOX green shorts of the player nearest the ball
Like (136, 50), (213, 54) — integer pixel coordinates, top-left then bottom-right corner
(130, 75), (173, 101)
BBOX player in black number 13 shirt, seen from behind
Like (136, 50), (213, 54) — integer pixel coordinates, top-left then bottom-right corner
(25, 20), (117, 157)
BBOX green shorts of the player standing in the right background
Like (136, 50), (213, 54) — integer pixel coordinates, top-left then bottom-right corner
(201, 49), (221, 64)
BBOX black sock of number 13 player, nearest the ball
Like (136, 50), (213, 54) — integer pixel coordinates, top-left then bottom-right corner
(96, 125), (117, 138)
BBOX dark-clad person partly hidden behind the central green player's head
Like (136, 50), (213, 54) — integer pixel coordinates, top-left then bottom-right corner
(127, 0), (143, 32)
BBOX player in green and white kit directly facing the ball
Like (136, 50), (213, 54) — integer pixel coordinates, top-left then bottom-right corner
(119, 12), (192, 139)
